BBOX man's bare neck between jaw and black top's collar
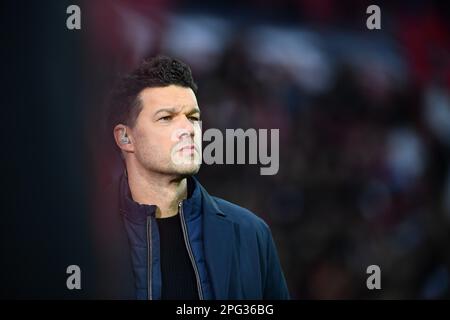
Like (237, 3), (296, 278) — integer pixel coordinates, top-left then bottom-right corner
(127, 160), (187, 218)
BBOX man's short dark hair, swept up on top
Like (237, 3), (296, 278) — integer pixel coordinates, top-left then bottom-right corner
(107, 56), (197, 132)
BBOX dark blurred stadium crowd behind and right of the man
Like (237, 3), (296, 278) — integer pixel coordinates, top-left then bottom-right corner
(89, 0), (450, 299)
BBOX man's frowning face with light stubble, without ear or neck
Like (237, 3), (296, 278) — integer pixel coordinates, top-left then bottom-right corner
(131, 85), (202, 176)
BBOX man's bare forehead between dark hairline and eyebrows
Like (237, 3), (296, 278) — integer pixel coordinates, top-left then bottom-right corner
(139, 85), (197, 112)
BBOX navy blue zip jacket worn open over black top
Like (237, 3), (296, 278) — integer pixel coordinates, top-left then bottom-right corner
(96, 176), (289, 300)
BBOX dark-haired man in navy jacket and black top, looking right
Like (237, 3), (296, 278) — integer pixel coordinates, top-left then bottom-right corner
(97, 56), (289, 300)
